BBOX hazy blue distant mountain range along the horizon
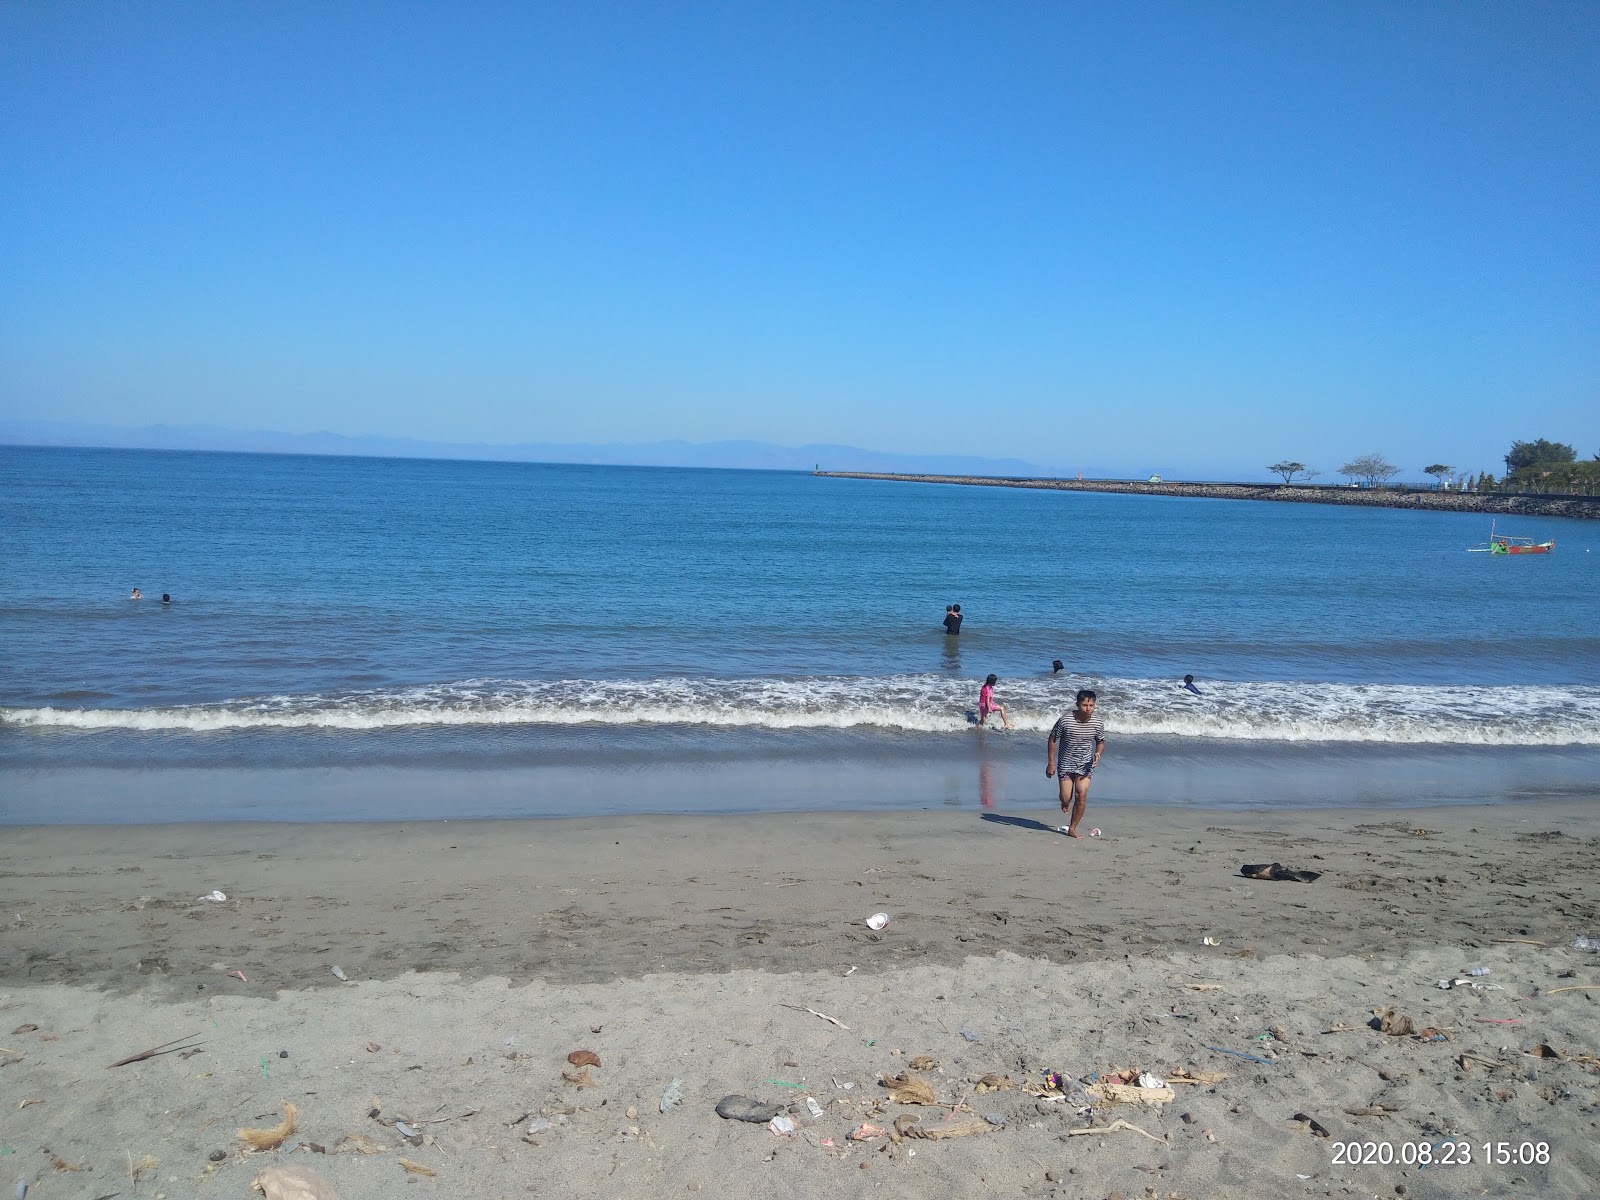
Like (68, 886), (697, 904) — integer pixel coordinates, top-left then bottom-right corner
(0, 421), (1069, 475)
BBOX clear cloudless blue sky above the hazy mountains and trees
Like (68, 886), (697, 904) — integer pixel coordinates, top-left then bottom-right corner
(0, 0), (1600, 477)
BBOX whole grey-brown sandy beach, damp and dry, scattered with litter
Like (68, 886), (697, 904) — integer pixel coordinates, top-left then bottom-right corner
(0, 802), (1600, 1200)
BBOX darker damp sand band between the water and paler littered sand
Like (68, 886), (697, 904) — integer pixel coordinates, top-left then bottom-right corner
(0, 797), (1600, 994)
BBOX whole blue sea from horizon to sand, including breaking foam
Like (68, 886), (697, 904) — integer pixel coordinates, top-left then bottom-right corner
(0, 446), (1600, 824)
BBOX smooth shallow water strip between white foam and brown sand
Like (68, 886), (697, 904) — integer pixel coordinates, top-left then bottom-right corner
(12, 734), (1600, 829)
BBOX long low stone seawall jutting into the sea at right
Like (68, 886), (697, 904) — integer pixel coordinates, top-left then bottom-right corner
(813, 470), (1600, 520)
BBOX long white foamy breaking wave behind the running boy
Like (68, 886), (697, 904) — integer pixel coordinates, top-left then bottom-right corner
(0, 675), (1600, 746)
